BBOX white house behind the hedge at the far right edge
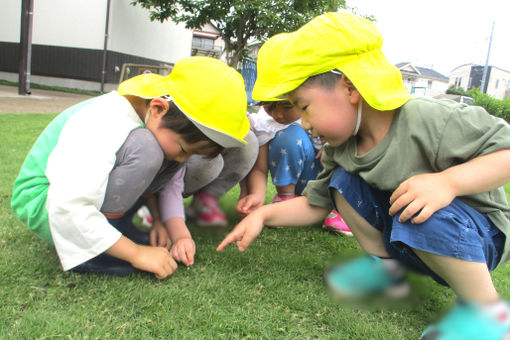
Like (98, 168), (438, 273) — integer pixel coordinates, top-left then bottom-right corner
(448, 64), (510, 99)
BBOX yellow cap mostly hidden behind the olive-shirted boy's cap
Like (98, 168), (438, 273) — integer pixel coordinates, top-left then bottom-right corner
(252, 33), (293, 101)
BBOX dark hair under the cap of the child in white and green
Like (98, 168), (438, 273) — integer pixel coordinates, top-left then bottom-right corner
(148, 100), (224, 158)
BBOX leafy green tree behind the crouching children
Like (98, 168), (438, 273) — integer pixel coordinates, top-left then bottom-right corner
(131, 0), (345, 67)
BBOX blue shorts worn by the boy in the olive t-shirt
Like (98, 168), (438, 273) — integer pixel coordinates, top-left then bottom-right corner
(329, 167), (505, 285)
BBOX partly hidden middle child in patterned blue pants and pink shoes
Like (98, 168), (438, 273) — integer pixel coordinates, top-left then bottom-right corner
(236, 33), (352, 236)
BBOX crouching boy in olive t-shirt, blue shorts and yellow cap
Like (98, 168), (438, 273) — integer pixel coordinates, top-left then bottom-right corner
(218, 13), (510, 340)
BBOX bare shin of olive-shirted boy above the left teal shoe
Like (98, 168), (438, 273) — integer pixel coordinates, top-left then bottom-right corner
(333, 191), (390, 257)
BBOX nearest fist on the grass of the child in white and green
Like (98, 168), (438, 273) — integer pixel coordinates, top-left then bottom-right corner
(131, 245), (177, 280)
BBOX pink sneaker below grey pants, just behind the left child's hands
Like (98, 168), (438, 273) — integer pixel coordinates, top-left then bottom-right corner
(186, 192), (227, 227)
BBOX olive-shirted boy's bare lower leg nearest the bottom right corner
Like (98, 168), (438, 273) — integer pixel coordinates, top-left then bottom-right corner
(413, 249), (499, 303)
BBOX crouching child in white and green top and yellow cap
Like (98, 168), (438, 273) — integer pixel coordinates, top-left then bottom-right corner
(11, 57), (249, 279)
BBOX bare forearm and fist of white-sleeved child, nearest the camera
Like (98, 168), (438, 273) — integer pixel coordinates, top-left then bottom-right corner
(106, 236), (177, 280)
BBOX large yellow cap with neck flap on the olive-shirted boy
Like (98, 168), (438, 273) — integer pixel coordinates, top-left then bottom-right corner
(253, 12), (411, 111)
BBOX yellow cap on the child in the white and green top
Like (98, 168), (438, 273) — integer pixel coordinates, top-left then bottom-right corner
(117, 57), (250, 148)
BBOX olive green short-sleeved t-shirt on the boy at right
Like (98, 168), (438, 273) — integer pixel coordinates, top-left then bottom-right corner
(303, 98), (510, 263)
